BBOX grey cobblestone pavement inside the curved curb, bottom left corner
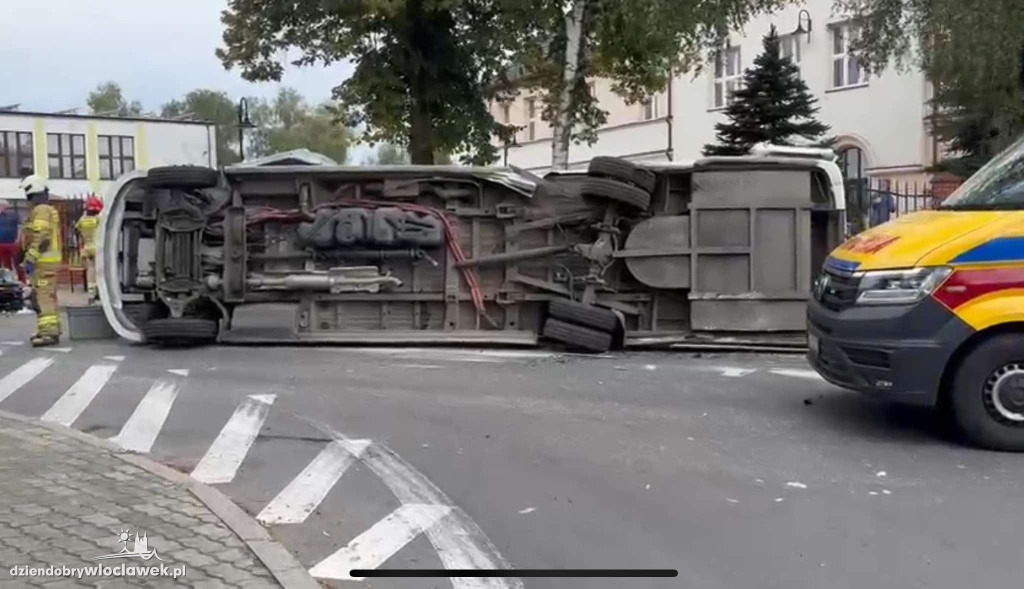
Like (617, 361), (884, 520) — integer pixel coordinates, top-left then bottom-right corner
(0, 417), (278, 589)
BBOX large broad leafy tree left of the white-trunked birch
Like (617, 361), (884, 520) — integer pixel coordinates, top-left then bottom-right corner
(217, 0), (527, 164)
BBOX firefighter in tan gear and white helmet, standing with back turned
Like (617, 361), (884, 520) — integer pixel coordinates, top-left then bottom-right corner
(18, 174), (61, 347)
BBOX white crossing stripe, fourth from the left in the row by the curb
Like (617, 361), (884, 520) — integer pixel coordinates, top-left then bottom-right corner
(191, 394), (278, 485)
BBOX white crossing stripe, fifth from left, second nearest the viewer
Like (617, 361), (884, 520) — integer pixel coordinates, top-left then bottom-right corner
(256, 439), (370, 523)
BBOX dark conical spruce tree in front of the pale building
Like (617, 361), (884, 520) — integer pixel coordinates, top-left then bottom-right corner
(703, 27), (834, 156)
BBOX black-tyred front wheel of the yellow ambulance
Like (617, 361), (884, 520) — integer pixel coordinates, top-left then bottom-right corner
(950, 334), (1024, 452)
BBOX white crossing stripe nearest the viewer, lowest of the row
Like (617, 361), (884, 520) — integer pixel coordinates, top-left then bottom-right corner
(309, 503), (452, 581)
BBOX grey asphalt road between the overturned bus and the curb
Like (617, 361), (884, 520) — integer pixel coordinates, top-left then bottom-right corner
(0, 317), (1024, 589)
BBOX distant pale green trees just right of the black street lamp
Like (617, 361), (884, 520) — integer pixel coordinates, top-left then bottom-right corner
(248, 88), (350, 164)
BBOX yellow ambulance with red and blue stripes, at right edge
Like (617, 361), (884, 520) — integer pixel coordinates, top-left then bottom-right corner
(807, 138), (1024, 451)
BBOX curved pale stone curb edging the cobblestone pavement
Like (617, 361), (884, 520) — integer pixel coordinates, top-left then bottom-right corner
(0, 411), (322, 589)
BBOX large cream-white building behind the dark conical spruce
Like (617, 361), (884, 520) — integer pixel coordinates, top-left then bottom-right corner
(493, 0), (941, 182)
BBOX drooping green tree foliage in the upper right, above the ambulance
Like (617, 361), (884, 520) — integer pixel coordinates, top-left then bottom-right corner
(837, 0), (1024, 175)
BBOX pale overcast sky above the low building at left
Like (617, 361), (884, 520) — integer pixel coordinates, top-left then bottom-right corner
(0, 0), (372, 161)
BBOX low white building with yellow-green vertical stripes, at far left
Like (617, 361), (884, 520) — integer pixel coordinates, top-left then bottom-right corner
(0, 111), (217, 200)
